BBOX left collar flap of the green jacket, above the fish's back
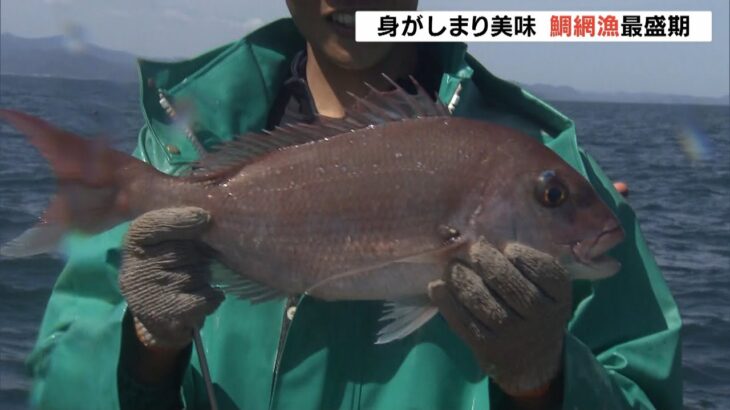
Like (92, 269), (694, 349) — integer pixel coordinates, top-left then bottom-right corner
(139, 19), (305, 165)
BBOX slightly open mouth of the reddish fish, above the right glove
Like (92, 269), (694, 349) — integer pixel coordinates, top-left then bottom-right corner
(566, 221), (624, 280)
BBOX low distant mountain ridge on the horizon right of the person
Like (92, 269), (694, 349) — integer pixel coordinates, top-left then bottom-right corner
(521, 84), (730, 105)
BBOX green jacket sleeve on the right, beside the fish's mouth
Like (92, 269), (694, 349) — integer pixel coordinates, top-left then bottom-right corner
(563, 152), (682, 410)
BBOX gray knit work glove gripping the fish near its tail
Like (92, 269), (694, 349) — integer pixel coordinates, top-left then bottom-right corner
(119, 207), (224, 348)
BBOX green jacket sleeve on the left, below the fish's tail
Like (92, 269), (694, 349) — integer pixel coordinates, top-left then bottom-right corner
(27, 128), (189, 410)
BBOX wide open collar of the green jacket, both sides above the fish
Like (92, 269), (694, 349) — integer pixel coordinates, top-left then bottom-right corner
(134, 18), (577, 173)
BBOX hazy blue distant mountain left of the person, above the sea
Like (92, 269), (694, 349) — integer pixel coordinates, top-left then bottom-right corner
(0, 33), (137, 82)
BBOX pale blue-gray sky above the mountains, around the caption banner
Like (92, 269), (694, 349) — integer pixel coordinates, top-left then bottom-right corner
(0, 0), (730, 96)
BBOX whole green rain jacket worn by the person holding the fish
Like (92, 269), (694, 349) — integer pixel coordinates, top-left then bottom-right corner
(28, 19), (682, 410)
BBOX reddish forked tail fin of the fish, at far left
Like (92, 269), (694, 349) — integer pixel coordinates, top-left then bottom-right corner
(0, 109), (152, 257)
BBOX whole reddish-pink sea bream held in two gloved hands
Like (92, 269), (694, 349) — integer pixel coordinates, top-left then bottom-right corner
(0, 80), (624, 343)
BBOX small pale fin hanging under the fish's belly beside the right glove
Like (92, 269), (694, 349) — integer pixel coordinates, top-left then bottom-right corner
(375, 297), (438, 344)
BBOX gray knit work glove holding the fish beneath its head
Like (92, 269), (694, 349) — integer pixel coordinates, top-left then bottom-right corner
(429, 239), (572, 396)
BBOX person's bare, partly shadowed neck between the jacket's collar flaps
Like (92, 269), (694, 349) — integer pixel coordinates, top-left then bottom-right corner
(306, 43), (416, 118)
